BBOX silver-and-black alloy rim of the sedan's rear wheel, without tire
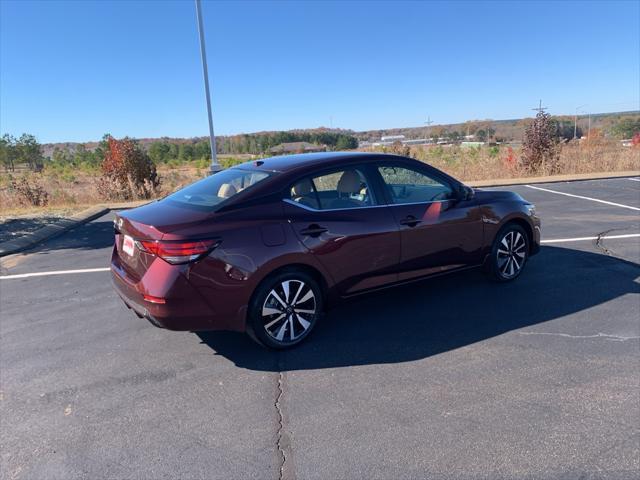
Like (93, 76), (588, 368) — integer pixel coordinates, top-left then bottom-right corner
(262, 280), (317, 343)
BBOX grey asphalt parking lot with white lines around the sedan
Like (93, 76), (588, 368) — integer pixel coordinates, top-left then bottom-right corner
(0, 178), (640, 479)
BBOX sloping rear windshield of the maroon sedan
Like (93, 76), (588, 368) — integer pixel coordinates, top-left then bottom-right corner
(166, 168), (272, 209)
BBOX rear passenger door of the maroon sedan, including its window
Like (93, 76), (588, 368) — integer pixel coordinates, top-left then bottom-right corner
(284, 166), (400, 295)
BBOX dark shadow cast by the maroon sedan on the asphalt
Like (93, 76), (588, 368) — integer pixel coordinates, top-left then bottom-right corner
(197, 247), (640, 371)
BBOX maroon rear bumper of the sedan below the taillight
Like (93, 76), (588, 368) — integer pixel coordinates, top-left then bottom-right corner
(111, 249), (245, 331)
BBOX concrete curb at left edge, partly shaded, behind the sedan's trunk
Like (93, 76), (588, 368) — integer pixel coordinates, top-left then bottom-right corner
(0, 200), (149, 257)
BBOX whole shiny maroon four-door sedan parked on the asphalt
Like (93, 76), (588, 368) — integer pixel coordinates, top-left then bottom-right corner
(111, 153), (540, 348)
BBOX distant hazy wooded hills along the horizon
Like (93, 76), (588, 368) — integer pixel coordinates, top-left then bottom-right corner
(42, 110), (640, 157)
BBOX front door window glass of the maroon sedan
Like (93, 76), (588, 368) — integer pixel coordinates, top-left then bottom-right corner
(378, 166), (453, 204)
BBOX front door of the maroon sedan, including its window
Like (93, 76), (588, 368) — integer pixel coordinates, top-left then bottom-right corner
(376, 163), (483, 280)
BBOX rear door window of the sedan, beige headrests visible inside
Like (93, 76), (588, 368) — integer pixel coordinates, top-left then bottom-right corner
(290, 168), (375, 210)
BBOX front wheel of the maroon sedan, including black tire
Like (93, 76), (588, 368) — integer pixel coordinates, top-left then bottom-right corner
(488, 223), (530, 282)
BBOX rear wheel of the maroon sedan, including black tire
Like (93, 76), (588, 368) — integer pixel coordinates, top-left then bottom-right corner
(248, 270), (324, 350)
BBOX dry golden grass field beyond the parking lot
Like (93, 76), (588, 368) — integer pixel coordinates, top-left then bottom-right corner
(0, 139), (640, 222)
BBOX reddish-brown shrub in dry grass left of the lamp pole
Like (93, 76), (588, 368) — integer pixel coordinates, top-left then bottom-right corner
(97, 137), (160, 200)
